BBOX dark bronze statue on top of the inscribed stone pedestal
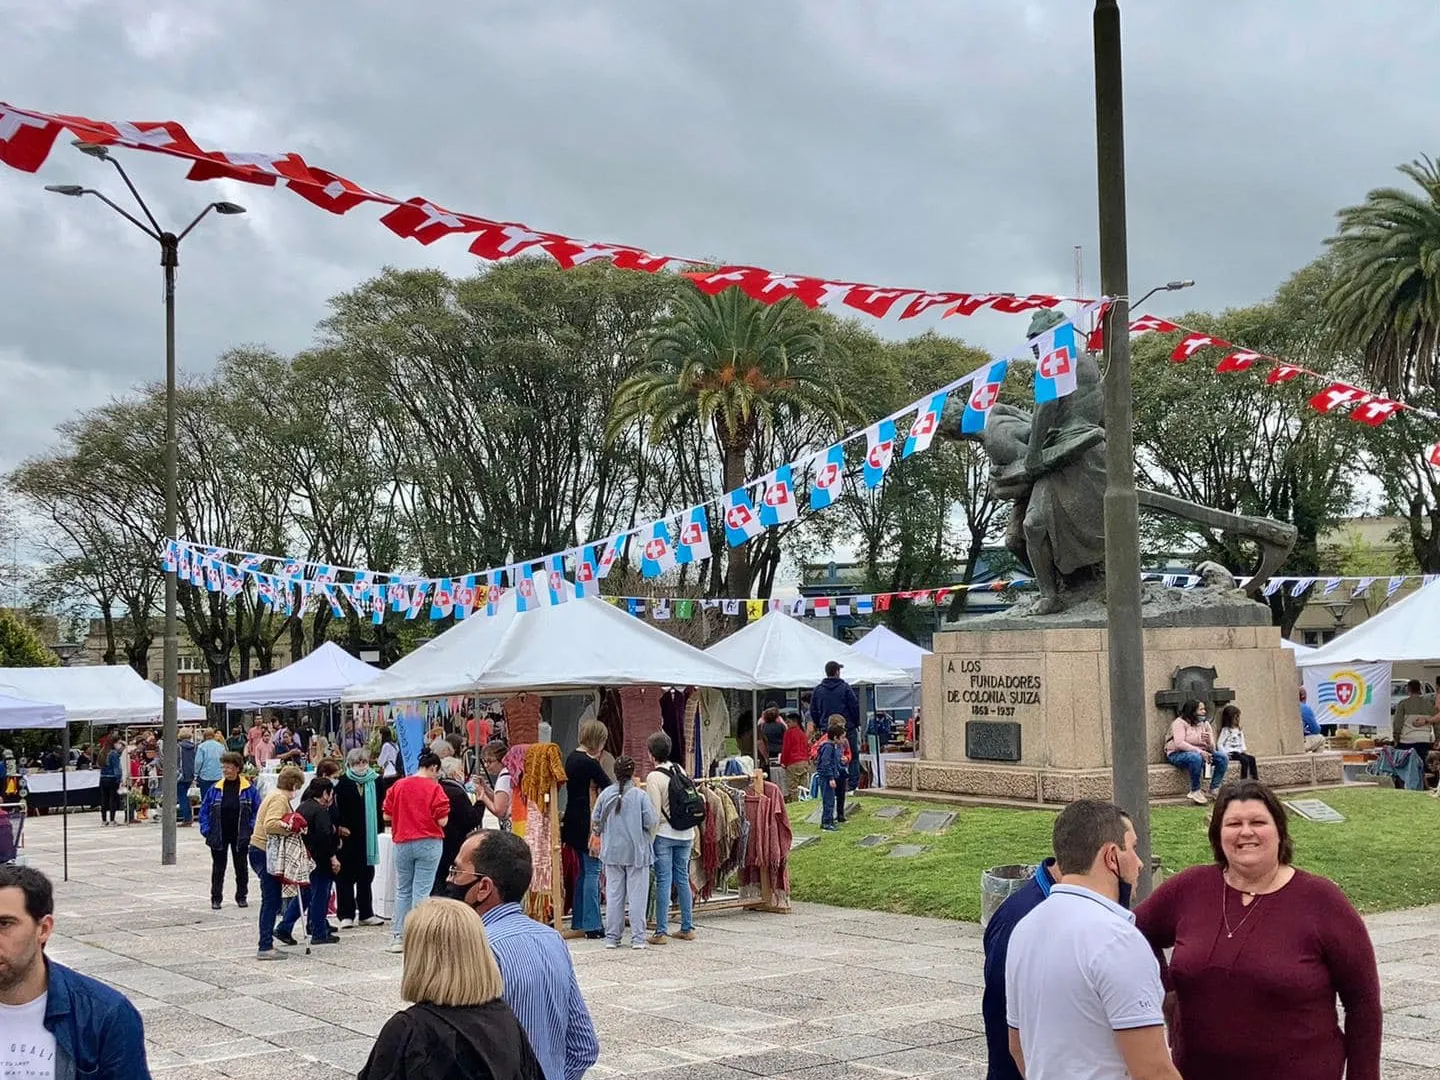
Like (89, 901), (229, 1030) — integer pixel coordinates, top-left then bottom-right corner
(940, 311), (1296, 615)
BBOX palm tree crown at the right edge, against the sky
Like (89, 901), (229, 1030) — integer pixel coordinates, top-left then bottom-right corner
(1325, 157), (1440, 393)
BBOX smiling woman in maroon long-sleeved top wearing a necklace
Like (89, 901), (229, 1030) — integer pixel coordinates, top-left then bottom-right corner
(1135, 780), (1381, 1080)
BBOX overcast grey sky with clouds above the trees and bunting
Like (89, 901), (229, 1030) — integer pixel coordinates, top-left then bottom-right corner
(0, 0), (1440, 469)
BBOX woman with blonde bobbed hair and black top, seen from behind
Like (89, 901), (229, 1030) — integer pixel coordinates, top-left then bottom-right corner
(359, 899), (544, 1080)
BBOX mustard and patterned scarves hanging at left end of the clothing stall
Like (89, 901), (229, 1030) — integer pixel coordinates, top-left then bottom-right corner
(504, 743), (566, 930)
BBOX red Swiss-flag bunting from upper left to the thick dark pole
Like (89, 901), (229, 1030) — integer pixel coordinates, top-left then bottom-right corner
(0, 102), (1089, 328)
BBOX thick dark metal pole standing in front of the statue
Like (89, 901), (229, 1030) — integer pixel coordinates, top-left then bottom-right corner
(1094, 0), (1151, 899)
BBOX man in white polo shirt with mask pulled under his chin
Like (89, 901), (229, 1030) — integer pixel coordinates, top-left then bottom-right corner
(1005, 799), (1181, 1080)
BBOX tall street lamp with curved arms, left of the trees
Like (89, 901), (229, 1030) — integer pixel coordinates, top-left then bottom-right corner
(45, 140), (245, 865)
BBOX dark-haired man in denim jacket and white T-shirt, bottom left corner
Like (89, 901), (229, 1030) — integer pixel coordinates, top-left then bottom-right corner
(0, 863), (150, 1080)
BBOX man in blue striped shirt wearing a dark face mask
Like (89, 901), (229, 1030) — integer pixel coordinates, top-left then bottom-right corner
(445, 829), (600, 1080)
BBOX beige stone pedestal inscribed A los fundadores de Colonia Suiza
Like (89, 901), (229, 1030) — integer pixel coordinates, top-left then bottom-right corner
(887, 622), (1342, 804)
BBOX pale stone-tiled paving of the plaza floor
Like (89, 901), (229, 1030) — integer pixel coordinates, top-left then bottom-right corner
(16, 815), (1440, 1080)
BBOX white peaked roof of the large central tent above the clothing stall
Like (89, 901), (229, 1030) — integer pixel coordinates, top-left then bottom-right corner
(340, 585), (753, 701)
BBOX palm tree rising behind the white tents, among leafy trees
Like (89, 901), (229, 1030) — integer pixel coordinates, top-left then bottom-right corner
(609, 288), (852, 596)
